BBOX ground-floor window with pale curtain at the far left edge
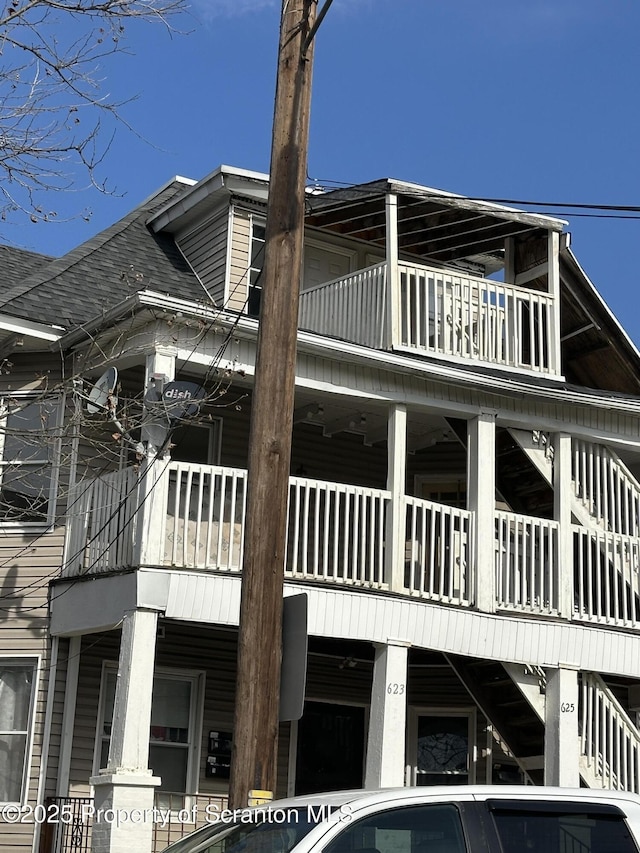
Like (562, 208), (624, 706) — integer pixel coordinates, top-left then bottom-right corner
(0, 658), (37, 803)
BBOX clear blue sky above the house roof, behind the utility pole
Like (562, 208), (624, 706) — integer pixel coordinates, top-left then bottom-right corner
(3, 0), (640, 344)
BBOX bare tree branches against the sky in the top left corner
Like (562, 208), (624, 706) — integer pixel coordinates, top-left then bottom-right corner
(0, 0), (187, 222)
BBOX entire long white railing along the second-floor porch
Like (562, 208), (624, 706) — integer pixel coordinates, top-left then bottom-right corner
(64, 462), (640, 628)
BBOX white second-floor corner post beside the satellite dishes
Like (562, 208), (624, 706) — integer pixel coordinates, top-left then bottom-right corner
(134, 347), (176, 566)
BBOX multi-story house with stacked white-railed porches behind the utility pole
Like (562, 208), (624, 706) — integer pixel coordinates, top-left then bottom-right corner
(0, 167), (640, 853)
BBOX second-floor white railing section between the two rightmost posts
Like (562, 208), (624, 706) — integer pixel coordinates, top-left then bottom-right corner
(495, 511), (560, 615)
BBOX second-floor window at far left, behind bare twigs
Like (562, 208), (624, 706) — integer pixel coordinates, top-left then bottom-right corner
(0, 397), (59, 526)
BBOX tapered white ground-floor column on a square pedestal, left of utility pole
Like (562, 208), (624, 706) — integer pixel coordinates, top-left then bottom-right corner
(90, 609), (160, 853)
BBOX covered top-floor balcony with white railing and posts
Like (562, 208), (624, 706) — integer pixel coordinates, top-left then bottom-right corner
(300, 180), (564, 376)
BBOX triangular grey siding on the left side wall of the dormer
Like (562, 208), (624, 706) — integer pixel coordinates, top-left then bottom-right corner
(176, 208), (229, 308)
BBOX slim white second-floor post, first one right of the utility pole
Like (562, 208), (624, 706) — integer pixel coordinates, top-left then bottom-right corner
(384, 405), (407, 592)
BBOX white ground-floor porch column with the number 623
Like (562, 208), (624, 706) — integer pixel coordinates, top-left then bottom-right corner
(364, 640), (409, 789)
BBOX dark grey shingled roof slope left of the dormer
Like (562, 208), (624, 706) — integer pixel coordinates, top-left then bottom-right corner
(0, 180), (203, 331)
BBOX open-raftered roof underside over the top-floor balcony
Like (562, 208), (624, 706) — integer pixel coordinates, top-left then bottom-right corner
(307, 181), (563, 269)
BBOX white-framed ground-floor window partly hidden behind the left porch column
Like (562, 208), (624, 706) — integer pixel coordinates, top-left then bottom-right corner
(94, 666), (204, 805)
